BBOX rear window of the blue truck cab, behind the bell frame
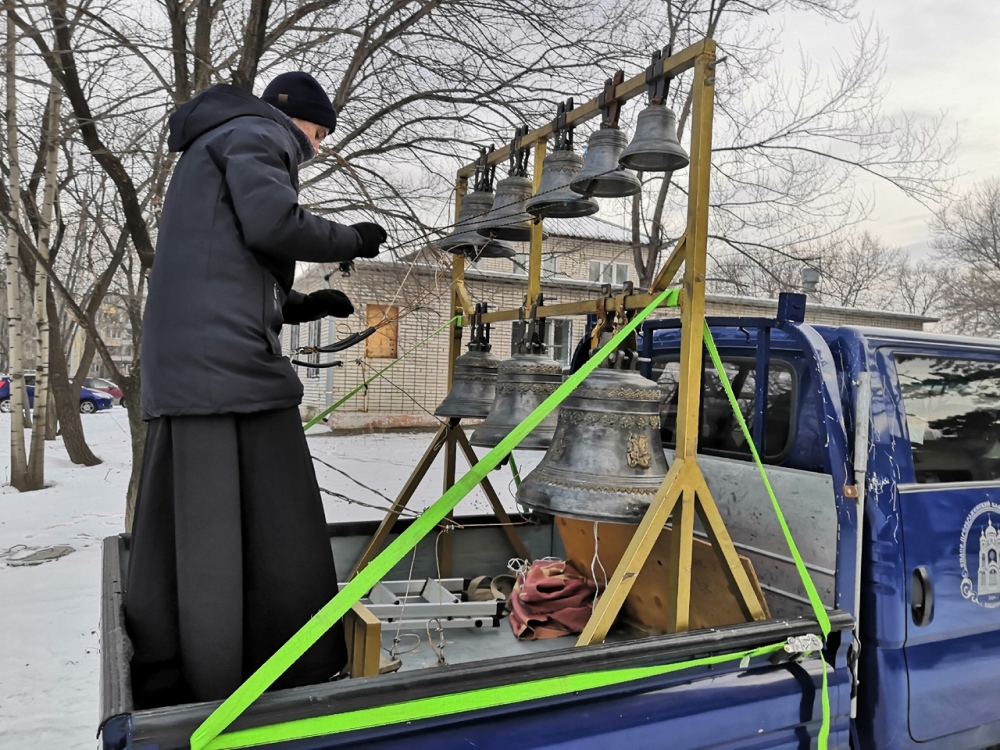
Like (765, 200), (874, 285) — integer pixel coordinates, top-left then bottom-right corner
(653, 357), (795, 463)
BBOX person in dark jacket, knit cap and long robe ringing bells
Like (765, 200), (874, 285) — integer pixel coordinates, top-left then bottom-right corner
(125, 73), (386, 707)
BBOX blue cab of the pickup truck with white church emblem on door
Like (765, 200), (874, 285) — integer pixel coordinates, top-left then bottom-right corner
(647, 319), (1000, 748)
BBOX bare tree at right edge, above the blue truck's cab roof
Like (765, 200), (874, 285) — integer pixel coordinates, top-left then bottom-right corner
(933, 178), (1000, 336)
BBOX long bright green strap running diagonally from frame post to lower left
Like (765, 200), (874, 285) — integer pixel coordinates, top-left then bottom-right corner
(191, 289), (680, 750)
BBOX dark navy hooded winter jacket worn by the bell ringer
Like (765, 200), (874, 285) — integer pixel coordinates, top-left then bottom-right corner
(141, 85), (361, 419)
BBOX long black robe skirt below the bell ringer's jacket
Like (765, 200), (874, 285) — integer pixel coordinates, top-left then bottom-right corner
(125, 408), (347, 708)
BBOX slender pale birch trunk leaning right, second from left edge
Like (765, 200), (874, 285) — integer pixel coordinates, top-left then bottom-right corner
(28, 78), (62, 490)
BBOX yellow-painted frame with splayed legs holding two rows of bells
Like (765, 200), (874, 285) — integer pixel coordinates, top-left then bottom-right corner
(359, 39), (767, 645)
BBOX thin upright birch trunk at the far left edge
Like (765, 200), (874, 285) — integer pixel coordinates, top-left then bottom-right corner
(5, 6), (28, 491)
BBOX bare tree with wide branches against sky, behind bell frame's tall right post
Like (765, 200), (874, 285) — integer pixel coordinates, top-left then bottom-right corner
(631, 0), (954, 285)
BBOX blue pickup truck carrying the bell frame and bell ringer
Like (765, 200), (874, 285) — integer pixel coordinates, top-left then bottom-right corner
(99, 310), (1000, 750)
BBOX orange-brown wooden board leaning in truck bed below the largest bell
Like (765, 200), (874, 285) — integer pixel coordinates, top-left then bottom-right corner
(555, 516), (770, 635)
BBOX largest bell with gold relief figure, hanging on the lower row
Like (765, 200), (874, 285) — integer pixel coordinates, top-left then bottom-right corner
(517, 368), (667, 524)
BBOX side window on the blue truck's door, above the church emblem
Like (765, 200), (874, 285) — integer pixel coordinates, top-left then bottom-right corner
(895, 354), (1000, 484)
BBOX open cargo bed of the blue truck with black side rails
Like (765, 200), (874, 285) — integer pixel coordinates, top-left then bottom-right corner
(101, 518), (853, 750)
